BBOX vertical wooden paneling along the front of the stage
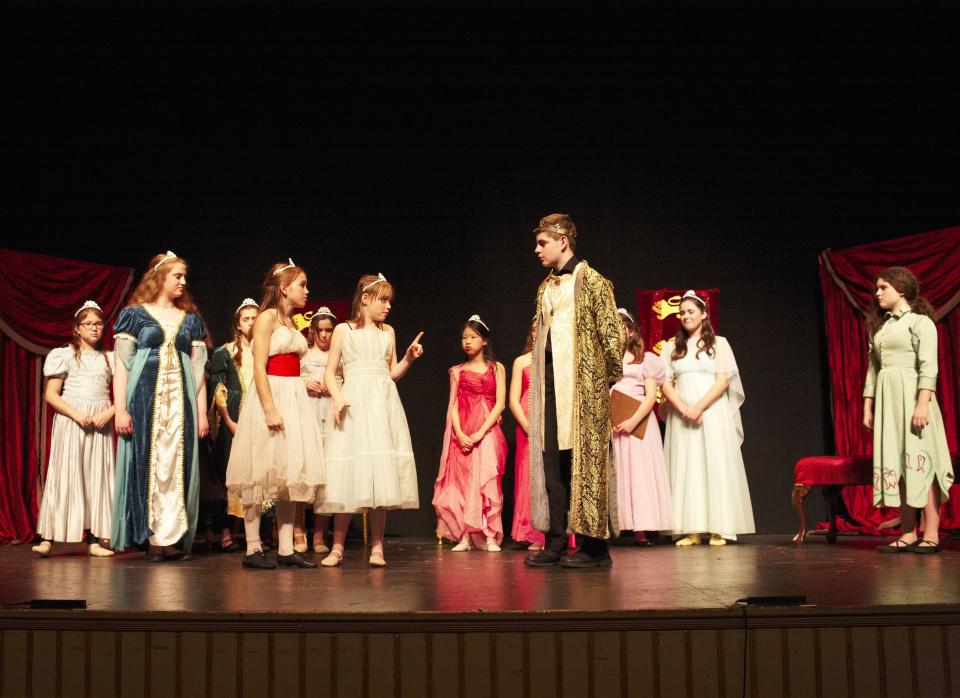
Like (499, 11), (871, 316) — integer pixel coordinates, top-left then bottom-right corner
(0, 625), (960, 698)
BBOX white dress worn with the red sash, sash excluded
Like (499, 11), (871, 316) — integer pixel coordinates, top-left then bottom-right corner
(227, 326), (325, 505)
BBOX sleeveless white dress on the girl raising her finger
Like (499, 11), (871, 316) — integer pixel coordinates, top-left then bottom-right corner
(314, 326), (420, 514)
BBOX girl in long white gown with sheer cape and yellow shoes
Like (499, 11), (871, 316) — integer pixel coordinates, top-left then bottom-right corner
(660, 291), (756, 546)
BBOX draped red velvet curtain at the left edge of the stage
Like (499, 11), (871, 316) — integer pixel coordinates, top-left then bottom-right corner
(0, 249), (133, 543)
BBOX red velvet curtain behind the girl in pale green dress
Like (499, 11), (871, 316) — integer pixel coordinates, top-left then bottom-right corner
(820, 227), (960, 534)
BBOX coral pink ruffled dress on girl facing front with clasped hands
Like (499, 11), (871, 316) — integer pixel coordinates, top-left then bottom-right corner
(433, 362), (507, 547)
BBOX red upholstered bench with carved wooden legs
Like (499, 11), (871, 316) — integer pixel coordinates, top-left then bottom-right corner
(790, 456), (873, 545)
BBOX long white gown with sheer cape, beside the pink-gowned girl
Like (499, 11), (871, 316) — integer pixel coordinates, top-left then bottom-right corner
(660, 337), (756, 539)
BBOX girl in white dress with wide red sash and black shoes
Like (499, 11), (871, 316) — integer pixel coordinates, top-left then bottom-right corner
(227, 260), (324, 569)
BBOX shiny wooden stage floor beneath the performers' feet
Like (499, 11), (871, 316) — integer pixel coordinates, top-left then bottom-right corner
(0, 536), (960, 616)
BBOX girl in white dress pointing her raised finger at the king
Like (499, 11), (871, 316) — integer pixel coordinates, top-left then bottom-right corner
(314, 274), (423, 567)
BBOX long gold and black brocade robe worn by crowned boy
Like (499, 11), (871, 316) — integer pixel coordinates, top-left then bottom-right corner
(529, 261), (625, 538)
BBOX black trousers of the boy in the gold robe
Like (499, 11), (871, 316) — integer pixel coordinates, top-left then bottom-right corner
(543, 352), (609, 557)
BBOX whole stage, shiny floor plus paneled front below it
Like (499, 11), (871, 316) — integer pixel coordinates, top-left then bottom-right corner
(0, 536), (960, 698)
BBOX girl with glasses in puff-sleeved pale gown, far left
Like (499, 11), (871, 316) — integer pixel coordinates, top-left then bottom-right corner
(33, 301), (114, 557)
